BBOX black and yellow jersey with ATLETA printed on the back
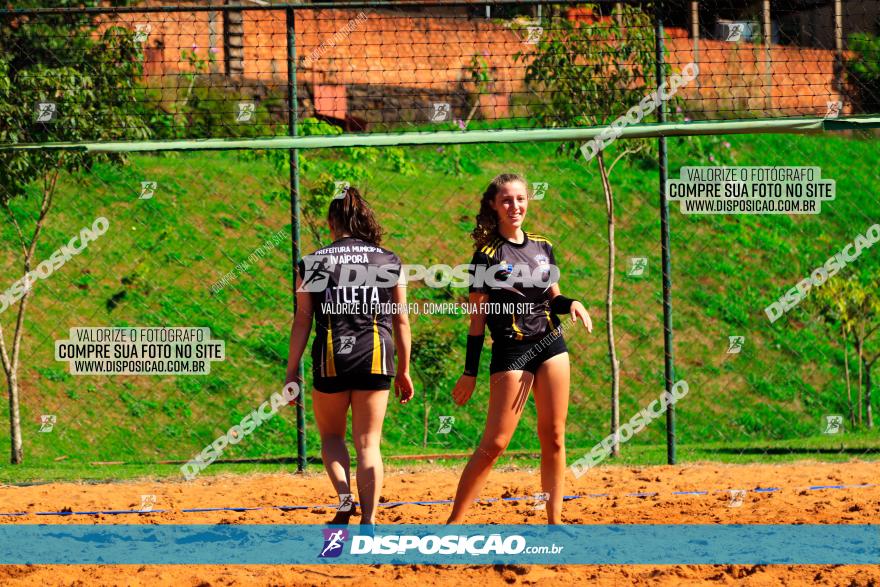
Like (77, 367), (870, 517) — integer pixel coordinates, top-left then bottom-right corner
(298, 236), (401, 377)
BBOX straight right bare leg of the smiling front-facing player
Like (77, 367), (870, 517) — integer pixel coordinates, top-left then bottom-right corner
(535, 353), (570, 524)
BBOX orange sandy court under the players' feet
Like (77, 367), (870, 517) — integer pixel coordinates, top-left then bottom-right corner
(0, 461), (880, 586)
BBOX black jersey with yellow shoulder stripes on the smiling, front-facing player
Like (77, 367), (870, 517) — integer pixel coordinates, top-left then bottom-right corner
(470, 232), (559, 342)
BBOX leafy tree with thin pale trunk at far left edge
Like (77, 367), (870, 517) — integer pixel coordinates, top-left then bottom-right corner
(0, 0), (150, 464)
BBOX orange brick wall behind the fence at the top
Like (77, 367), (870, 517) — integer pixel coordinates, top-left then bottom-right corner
(103, 9), (852, 123)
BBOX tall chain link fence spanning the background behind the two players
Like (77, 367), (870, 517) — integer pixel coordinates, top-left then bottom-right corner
(0, 2), (880, 464)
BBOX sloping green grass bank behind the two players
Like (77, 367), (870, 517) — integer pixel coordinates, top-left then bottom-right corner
(0, 125), (880, 480)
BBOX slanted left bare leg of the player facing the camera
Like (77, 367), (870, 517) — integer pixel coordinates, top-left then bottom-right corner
(446, 371), (534, 524)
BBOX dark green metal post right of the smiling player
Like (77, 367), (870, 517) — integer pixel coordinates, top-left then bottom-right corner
(654, 0), (675, 465)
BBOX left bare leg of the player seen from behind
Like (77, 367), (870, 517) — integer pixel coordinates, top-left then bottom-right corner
(312, 390), (354, 524)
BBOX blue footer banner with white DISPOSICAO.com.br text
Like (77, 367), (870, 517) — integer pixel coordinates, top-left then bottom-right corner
(0, 524), (880, 565)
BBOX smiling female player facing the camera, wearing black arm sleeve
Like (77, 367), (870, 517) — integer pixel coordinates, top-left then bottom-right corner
(447, 174), (593, 524)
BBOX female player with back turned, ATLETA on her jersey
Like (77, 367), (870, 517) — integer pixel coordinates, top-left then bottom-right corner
(285, 187), (413, 524)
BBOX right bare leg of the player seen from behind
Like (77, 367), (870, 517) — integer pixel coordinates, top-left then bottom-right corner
(351, 389), (388, 524)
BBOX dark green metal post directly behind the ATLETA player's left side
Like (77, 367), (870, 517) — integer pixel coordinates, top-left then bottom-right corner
(284, 6), (306, 473)
